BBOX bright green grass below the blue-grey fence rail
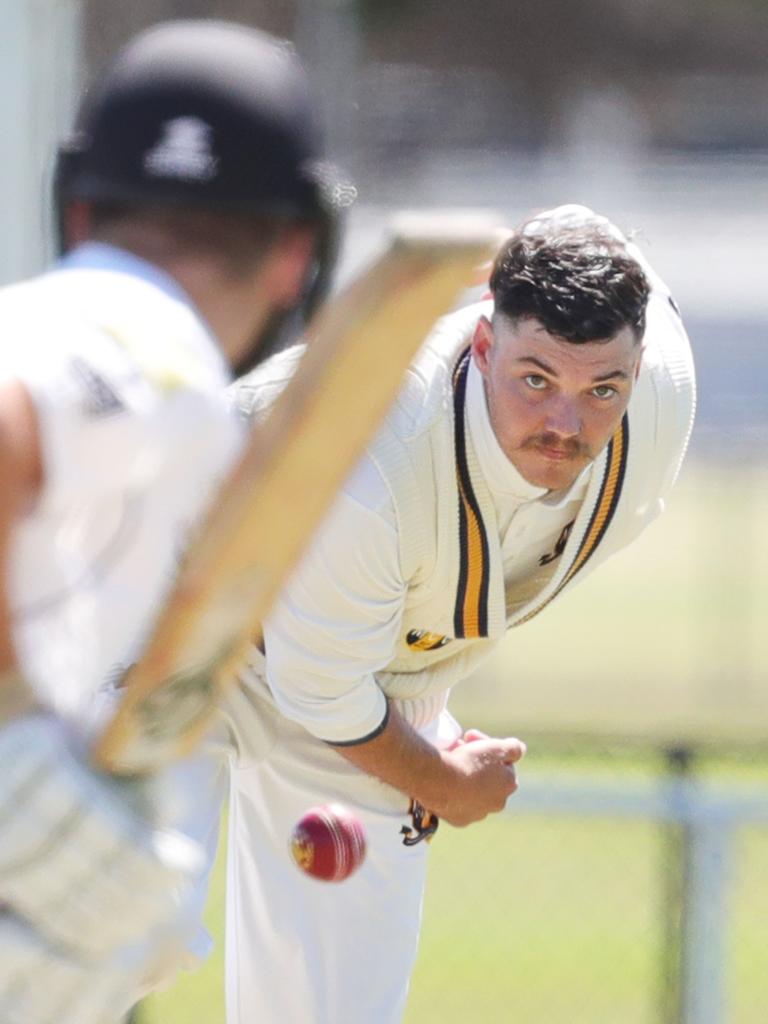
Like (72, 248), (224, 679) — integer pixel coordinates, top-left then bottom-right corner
(141, 778), (768, 1024)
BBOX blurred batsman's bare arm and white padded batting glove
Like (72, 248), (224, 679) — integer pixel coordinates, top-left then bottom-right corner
(0, 380), (207, 974)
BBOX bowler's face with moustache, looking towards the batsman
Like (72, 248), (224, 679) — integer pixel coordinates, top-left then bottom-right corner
(472, 316), (642, 490)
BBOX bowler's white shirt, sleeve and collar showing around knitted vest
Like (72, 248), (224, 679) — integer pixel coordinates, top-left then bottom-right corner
(264, 364), (590, 741)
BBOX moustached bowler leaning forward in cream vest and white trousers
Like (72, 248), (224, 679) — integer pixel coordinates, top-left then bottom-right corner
(191, 206), (694, 1024)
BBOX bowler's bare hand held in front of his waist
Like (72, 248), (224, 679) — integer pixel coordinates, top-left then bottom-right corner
(430, 729), (525, 827)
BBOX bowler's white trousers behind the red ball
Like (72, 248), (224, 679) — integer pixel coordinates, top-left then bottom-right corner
(226, 684), (456, 1024)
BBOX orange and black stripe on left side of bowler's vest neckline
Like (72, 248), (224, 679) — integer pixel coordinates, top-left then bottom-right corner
(454, 348), (490, 639)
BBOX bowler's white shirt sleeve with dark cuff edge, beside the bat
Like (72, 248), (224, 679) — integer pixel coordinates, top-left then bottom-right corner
(264, 459), (406, 744)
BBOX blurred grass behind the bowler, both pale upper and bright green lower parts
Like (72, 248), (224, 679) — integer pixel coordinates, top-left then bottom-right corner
(141, 467), (768, 1024)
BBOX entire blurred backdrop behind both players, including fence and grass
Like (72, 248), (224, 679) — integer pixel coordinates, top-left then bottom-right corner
(7, 0), (768, 1024)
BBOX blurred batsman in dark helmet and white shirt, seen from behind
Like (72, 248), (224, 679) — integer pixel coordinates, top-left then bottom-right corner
(0, 20), (346, 1024)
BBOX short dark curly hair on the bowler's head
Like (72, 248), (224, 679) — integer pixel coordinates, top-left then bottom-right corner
(490, 217), (650, 343)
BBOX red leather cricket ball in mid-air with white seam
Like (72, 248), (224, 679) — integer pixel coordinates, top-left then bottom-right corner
(291, 804), (366, 882)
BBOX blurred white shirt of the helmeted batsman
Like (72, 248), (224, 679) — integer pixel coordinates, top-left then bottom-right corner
(0, 244), (242, 718)
